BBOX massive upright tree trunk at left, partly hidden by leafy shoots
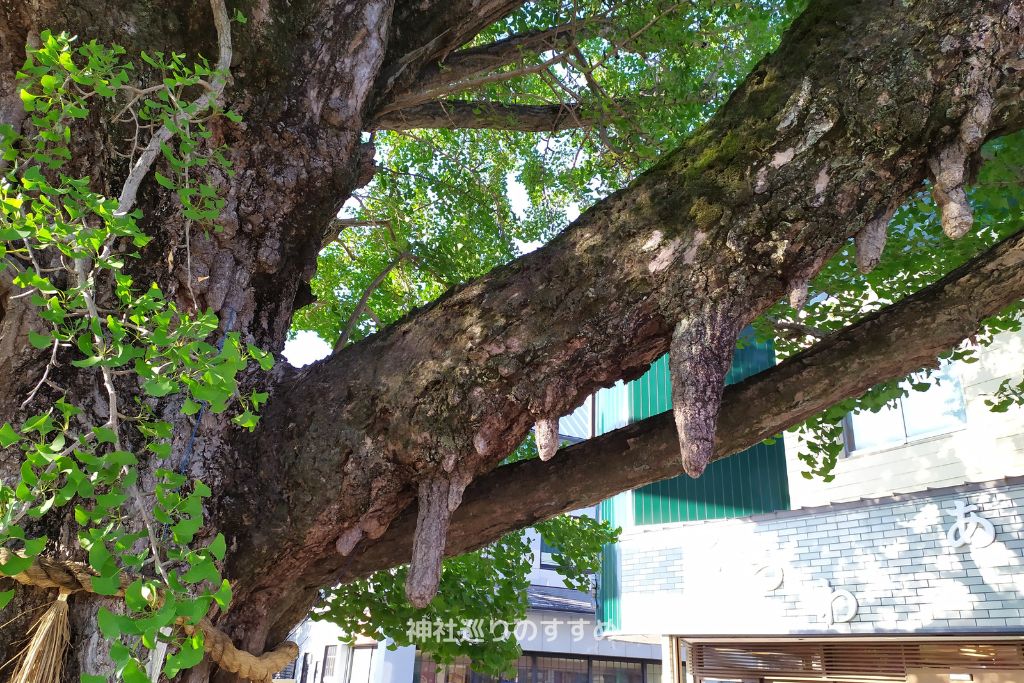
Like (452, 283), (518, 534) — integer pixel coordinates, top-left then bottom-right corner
(0, 0), (390, 681)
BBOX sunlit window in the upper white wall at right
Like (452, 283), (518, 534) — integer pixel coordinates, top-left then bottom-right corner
(845, 364), (967, 453)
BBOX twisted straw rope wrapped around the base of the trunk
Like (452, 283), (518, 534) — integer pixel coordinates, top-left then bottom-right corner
(0, 548), (299, 683)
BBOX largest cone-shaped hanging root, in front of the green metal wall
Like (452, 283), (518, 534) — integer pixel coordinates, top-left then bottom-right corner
(669, 315), (739, 478)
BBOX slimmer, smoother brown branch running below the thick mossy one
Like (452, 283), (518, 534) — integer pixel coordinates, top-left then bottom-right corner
(319, 227), (1024, 582)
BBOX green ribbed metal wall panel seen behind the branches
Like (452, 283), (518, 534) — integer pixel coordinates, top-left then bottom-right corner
(616, 336), (790, 524)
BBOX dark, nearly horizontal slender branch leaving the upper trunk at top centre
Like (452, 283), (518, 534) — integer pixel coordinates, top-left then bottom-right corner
(368, 99), (598, 133)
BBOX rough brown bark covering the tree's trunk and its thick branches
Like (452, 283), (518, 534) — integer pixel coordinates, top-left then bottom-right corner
(0, 0), (1024, 681)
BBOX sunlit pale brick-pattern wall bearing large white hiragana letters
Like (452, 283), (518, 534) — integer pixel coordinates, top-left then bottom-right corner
(620, 481), (1024, 635)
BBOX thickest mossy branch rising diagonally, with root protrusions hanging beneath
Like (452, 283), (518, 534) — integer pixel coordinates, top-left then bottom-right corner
(234, 0), (1024, 647)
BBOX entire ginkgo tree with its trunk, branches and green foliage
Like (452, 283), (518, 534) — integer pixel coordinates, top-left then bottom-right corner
(0, 0), (1024, 681)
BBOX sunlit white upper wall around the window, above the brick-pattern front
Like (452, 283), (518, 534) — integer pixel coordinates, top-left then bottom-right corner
(785, 333), (1024, 508)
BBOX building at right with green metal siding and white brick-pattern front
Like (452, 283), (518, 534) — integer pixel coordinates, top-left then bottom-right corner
(597, 334), (1024, 683)
